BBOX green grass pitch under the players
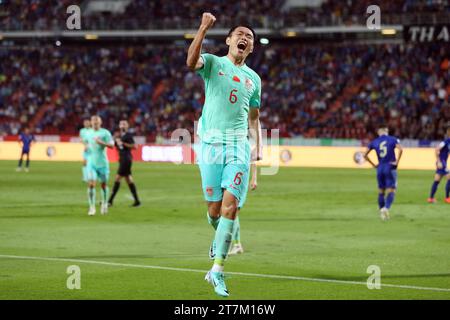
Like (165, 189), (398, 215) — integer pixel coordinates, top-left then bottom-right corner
(0, 161), (450, 300)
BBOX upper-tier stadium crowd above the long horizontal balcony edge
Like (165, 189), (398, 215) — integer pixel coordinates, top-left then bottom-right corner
(0, 0), (450, 30)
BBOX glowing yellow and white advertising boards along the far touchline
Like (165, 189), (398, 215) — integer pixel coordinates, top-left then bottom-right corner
(0, 141), (435, 170)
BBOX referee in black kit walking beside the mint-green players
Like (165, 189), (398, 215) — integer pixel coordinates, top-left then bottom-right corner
(108, 120), (141, 207)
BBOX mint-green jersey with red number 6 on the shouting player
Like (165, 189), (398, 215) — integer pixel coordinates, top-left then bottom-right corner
(197, 53), (261, 143)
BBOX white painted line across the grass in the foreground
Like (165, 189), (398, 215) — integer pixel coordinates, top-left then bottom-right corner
(0, 254), (450, 293)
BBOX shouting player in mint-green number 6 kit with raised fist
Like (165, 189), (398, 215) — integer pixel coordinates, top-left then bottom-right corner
(186, 13), (261, 297)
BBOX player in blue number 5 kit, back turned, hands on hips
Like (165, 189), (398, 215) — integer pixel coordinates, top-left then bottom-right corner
(364, 126), (403, 221)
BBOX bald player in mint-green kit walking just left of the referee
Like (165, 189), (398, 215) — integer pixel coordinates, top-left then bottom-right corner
(88, 116), (114, 216)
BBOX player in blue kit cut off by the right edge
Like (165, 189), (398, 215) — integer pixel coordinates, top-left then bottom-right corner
(428, 128), (450, 203)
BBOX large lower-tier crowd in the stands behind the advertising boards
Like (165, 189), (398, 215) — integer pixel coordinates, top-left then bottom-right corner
(0, 40), (450, 141)
